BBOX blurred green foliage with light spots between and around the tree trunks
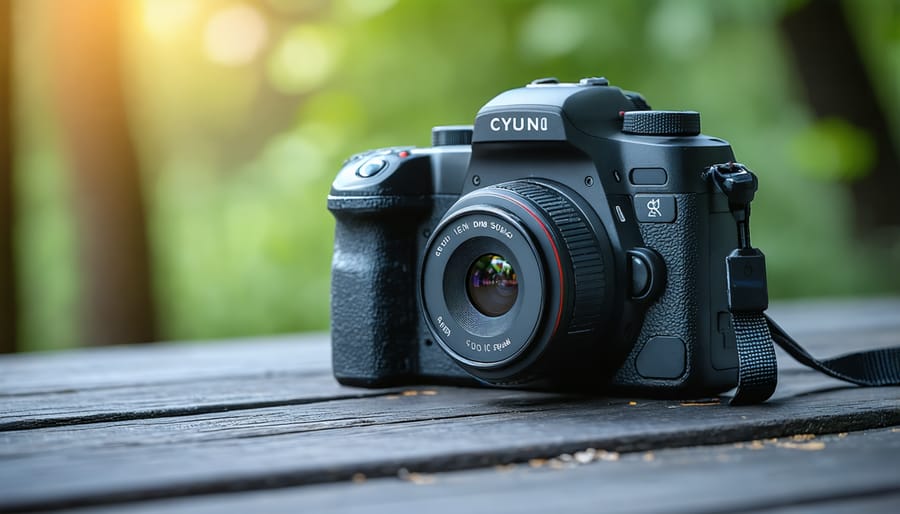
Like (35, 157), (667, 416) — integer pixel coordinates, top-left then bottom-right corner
(16, 0), (900, 349)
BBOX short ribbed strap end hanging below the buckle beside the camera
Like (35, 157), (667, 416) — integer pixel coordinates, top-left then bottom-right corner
(729, 312), (778, 405)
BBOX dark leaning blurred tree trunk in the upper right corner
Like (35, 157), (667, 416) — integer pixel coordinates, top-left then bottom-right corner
(781, 0), (900, 232)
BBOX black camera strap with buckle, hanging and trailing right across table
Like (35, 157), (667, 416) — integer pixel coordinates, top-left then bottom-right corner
(704, 163), (900, 405)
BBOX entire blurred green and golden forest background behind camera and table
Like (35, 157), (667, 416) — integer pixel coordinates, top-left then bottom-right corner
(0, 0), (900, 351)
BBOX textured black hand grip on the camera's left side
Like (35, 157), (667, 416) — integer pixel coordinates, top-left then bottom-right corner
(331, 211), (419, 387)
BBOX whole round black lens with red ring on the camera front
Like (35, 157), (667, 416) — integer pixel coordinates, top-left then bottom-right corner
(419, 180), (613, 385)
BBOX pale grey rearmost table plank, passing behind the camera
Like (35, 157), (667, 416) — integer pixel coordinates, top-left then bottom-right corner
(0, 299), (900, 430)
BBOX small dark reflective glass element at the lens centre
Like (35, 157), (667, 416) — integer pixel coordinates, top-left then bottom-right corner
(466, 254), (519, 317)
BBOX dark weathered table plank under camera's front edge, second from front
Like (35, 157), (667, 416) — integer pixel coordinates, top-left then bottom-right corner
(0, 380), (900, 510)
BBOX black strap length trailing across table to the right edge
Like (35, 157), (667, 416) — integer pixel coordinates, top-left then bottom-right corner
(765, 316), (900, 387)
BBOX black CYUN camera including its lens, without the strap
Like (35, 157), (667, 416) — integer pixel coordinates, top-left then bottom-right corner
(328, 78), (738, 397)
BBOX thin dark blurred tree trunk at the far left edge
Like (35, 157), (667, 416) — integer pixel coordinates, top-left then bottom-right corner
(0, 0), (18, 353)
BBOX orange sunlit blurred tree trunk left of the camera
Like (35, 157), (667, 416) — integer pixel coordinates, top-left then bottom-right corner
(48, 0), (156, 345)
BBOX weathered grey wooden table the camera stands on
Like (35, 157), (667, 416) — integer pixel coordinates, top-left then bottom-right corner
(0, 299), (900, 514)
